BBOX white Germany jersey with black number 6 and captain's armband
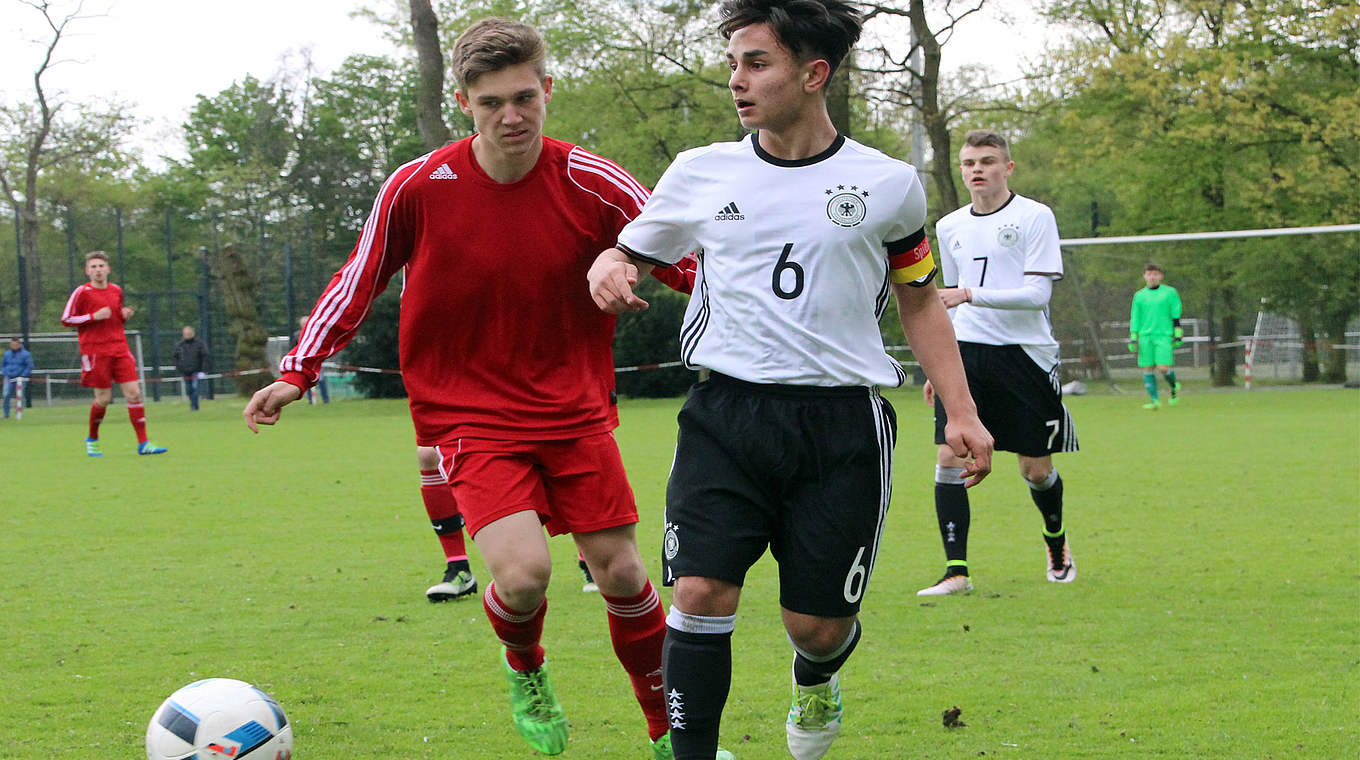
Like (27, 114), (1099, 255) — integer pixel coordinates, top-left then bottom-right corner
(619, 136), (934, 386)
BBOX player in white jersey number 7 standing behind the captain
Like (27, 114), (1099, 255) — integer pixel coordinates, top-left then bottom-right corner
(917, 129), (1077, 597)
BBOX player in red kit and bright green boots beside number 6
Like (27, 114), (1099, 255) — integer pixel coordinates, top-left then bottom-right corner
(243, 19), (701, 759)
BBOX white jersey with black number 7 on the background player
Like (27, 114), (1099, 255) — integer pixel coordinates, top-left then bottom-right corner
(936, 193), (1062, 370)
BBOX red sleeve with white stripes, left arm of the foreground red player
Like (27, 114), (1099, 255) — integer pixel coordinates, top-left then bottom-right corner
(279, 154), (432, 389)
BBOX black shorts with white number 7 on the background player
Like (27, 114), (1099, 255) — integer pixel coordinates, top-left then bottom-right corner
(936, 343), (1077, 457)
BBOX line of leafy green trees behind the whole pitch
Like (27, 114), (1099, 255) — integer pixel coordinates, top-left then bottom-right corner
(0, 0), (1360, 393)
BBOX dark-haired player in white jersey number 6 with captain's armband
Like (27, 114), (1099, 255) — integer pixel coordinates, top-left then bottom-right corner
(589, 0), (991, 760)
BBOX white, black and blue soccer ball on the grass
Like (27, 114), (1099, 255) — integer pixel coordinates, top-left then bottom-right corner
(147, 678), (292, 760)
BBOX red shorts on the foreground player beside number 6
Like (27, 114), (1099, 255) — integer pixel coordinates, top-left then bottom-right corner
(435, 432), (638, 537)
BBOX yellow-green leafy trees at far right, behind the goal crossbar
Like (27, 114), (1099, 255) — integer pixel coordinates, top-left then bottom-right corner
(1035, 0), (1360, 385)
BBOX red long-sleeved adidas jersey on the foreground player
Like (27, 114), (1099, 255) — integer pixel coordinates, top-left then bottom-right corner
(280, 137), (647, 446)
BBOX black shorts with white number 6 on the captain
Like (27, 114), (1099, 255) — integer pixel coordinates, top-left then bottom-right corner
(661, 373), (898, 617)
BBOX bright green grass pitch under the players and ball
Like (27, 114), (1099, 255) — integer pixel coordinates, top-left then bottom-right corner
(0, 389), (1360, 760)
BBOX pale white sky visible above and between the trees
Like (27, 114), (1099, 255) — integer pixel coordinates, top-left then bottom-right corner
(0, 0), (1035, 158)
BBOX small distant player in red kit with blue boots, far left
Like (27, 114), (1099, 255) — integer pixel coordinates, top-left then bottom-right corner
(61, 250), (166, 457)
